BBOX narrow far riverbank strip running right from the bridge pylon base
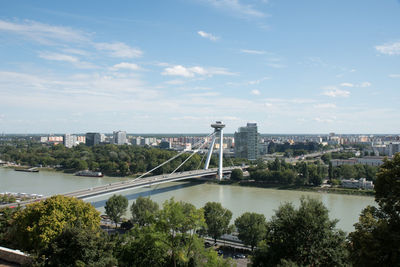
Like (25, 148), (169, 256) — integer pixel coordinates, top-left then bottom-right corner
(208, 180), (375, 197)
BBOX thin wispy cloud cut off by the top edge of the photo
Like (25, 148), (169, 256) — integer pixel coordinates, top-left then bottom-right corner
(204, 0), (266, 18)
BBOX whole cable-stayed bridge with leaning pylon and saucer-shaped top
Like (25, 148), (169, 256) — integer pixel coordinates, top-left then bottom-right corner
(0, 121), (248, 208)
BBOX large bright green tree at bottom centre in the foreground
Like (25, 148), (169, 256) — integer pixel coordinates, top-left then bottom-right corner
(115, 199), (231, 267)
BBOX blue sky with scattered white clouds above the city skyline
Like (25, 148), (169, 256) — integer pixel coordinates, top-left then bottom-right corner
(0, 0), (400, 134)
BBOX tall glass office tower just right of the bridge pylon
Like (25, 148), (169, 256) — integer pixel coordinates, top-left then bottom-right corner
(235, 123), (259, 160)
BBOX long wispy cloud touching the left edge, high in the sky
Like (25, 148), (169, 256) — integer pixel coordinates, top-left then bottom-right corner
(0, 20), (89, 44)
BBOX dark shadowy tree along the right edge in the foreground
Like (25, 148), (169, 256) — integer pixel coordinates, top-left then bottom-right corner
(349, 153), (400, 266)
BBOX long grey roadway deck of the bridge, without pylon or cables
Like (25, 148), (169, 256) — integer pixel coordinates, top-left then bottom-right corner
(0, 167), (241, 208)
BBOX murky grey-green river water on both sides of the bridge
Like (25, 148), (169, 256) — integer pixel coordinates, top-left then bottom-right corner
(0, 168), (375, 232)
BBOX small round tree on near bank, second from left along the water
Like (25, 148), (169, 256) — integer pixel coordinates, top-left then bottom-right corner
(131, 196), (159, 226)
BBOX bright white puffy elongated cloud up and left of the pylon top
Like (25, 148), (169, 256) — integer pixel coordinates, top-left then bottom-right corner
(161, 65), (234, 78)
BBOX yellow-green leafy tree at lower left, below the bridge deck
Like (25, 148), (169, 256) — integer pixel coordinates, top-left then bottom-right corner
(12, 195), (100, 251)
